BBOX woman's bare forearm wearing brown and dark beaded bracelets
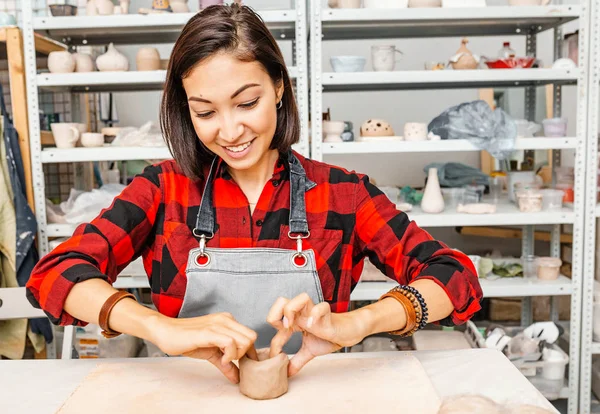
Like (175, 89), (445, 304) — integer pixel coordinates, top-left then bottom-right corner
(350, 279), (454, 336)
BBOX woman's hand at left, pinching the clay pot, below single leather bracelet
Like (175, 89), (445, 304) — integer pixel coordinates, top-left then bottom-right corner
(150, 313), (258, 384)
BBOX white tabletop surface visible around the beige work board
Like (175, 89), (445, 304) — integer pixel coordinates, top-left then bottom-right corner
(0, 349), (558, 414)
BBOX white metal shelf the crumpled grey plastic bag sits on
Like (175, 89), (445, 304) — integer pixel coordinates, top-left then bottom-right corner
(321, 137), (577, 156)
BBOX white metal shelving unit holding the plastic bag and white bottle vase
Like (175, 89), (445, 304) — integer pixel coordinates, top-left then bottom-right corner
(310, 0), (588, 414)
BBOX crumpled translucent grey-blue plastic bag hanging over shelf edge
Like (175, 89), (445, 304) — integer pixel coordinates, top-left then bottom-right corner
(428, 100), (517, 160)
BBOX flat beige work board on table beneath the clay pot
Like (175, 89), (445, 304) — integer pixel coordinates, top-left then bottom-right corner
(58, 352), (440, 414)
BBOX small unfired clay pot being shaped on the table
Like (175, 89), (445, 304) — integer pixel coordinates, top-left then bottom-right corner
(240, 348), (289, 400)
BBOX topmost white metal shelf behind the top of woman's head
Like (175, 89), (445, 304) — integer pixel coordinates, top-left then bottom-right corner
(33, 10), (297, 45)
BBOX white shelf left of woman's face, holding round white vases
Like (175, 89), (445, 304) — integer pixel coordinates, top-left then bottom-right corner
(37, 66), (298, 92)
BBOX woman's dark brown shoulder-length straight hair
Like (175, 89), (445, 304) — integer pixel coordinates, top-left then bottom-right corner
(160, 4), (300, 178)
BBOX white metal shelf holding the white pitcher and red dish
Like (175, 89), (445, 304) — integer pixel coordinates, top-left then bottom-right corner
(322, 69), (579, 92)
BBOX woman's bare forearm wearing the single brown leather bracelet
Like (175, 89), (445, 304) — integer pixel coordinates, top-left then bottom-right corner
(64, 279), (163, 340)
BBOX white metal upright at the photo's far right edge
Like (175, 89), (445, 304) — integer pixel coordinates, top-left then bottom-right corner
(579, 0), (600, 413)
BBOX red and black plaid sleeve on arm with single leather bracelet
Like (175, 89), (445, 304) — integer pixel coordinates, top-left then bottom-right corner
(26, 166), (161, 326)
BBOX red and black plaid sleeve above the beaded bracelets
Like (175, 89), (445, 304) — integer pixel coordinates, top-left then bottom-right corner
(356, 176), (483, 326)
